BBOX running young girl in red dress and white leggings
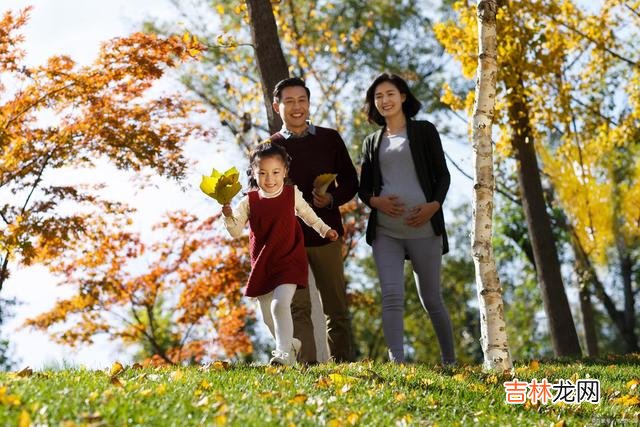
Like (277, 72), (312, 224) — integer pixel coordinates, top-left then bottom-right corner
(222, 143), (338, 365)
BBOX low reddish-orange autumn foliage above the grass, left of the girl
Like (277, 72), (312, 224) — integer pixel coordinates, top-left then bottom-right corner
(26, 212), (252, 363)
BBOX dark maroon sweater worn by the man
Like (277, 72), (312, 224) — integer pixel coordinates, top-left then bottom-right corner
(271, 126), (358, 246)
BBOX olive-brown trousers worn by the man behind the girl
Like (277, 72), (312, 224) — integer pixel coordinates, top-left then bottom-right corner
(291, 240), (355, 363)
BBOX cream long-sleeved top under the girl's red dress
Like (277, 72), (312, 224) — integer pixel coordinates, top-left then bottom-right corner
(223, 185), (331, 238)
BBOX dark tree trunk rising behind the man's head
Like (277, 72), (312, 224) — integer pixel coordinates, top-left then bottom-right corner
(247, 0), (289, 133)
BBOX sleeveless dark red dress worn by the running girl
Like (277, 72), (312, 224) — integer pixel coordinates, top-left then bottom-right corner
(245, 185), (309, 297)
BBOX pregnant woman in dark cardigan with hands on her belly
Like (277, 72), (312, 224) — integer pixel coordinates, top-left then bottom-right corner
(358, 73), (455, 365)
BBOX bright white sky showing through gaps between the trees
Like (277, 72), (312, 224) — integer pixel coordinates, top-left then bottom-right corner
(0, 0), (471, 369)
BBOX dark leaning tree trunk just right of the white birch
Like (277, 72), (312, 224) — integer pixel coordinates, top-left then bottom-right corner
(508, 81), (581, 356)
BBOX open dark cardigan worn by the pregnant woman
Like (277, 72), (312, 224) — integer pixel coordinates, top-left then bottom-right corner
(358, 120), (451, 254)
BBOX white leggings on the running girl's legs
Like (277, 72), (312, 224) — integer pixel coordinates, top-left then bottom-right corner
(258, 284), (297, 353)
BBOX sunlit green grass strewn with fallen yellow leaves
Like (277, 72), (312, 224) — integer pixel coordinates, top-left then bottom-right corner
(0, 355), (640, 426)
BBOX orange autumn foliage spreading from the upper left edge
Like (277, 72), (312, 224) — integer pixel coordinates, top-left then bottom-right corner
(0, 9), (205, 289)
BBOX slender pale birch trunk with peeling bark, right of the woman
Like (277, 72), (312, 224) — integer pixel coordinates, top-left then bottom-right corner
(471, 0), (512, 371)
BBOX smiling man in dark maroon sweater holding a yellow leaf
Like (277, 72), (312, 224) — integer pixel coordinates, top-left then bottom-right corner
(270, 77), (358, 363)
